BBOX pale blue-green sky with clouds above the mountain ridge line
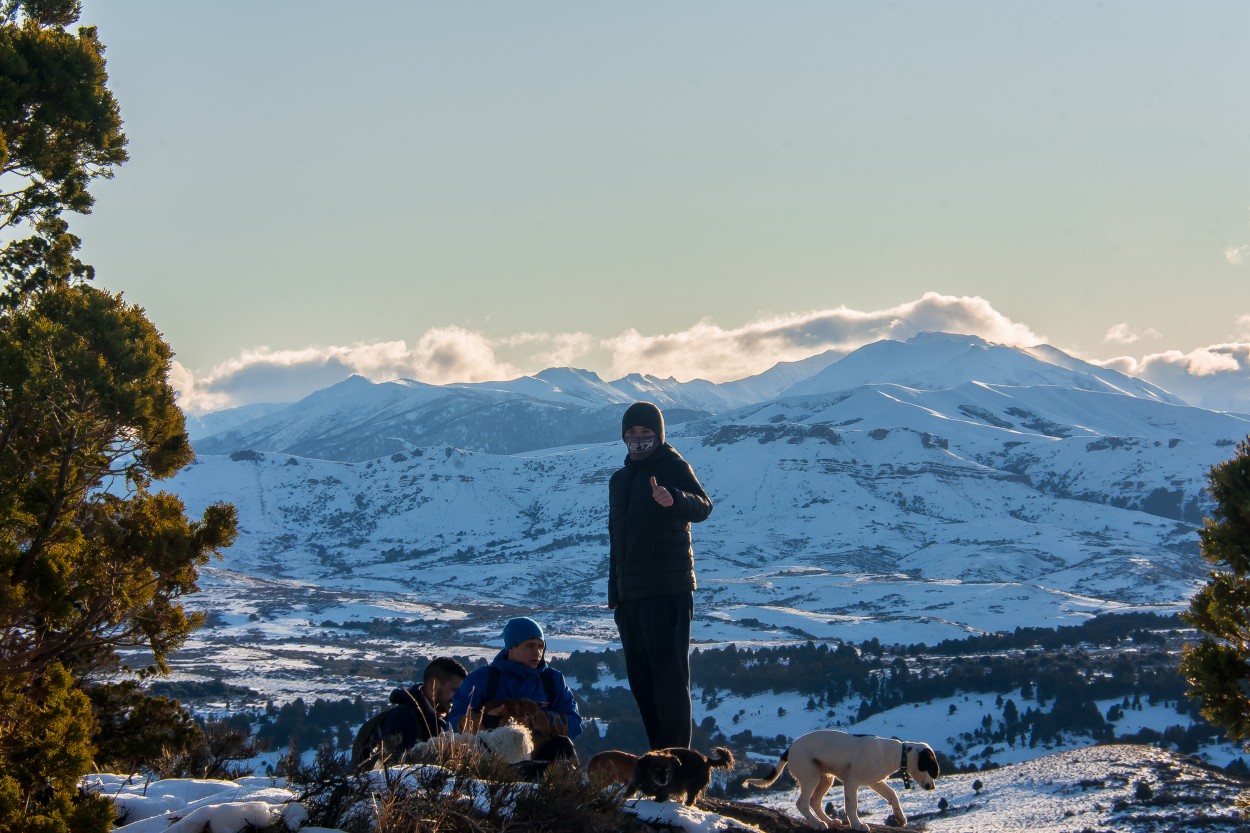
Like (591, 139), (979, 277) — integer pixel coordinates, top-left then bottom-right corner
(63, 0), (1250, 413)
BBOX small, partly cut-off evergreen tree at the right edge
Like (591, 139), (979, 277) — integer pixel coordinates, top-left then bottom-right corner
(1180, 439), (1250, 740)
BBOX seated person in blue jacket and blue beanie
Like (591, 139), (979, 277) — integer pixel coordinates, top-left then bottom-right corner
(448, 617), (581, 760)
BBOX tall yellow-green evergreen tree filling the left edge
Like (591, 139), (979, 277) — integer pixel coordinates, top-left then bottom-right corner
(0, 0), (235, 833)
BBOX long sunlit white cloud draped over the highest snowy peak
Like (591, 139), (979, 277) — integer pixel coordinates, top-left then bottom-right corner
(603, 293), (1045, 381)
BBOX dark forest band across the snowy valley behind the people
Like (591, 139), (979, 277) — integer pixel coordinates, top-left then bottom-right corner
(153, 613), (1243, 770)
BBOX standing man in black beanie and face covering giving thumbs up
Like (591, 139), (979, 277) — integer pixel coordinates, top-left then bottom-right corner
(608, 401), (711, 749)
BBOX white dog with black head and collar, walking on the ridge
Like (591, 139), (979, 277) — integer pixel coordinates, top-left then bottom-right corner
(743, 729), (938, 830)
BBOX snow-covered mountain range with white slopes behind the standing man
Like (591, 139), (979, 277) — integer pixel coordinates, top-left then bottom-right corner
(171, 334), (1250, 685)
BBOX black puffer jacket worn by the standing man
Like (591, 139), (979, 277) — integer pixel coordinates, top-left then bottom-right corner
(608, 443), (711, 608)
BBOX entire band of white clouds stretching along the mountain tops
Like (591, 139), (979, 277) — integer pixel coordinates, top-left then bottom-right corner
(170, 293), (1250, 413)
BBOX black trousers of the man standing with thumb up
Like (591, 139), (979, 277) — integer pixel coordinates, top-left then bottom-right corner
(615, 593), (695, 749)
